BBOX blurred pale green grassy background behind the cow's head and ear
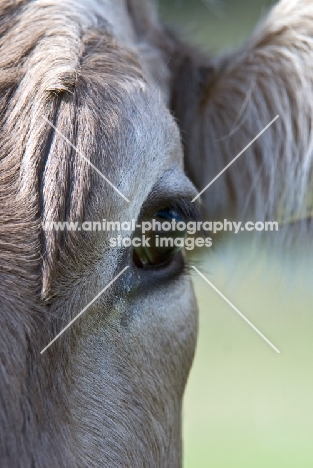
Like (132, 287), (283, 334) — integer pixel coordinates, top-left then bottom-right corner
(159, 0), (313, 468)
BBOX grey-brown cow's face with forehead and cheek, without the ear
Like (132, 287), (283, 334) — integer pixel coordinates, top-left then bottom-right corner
(0, 1), (196, 468)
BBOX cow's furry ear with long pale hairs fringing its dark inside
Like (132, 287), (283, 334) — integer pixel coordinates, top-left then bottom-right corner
(172, 0), (313, 229)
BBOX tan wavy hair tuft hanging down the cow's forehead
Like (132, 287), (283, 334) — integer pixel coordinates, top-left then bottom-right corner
(0, 1), (145, 294)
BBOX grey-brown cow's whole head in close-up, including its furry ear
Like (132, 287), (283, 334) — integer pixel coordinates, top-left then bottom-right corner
(0, 0), (313, 468)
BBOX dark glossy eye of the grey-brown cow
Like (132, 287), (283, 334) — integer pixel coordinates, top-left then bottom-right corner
(133, 209), (187, 268)
